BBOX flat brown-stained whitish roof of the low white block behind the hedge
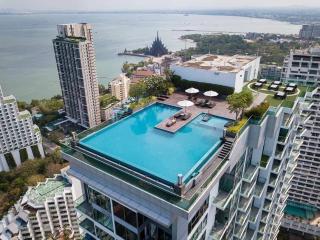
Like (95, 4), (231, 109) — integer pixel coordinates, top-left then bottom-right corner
(175, 54), (258, 73)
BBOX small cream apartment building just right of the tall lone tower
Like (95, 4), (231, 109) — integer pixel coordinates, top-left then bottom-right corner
(109, 74), (130, 101)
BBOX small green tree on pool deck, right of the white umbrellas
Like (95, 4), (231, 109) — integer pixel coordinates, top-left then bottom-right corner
(227, 91), (253, 120)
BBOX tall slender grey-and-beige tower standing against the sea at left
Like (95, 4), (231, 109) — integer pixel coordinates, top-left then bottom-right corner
(53, 23), (101, 128)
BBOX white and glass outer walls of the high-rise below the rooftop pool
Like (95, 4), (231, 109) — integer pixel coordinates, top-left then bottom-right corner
(62, 95), (297, 240)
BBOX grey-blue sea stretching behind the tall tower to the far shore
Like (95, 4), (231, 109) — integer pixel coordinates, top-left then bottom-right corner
(0, 13), (301, 101)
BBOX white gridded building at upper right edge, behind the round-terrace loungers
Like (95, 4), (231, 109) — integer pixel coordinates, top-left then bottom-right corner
(281, 47), (320, 86)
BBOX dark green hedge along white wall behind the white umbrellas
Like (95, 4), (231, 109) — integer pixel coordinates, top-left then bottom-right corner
(171, 75), (234, 97)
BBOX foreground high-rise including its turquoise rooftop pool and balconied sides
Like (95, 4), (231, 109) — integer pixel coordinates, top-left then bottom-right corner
(62, 87), (299, 240)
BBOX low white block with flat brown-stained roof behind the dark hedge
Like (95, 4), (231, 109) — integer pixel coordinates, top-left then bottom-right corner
(170, 54), (260, 92)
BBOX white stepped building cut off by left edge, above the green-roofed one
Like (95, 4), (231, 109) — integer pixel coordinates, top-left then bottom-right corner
(0, 83), (44, 171)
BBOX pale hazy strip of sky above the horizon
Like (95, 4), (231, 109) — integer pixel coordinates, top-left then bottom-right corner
(0, 0), (320, 11)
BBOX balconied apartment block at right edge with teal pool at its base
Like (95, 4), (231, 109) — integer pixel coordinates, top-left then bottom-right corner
(282, 88), (320, 237)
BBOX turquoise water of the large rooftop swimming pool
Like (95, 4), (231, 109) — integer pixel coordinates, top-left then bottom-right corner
(80, 103), (230, 183)
